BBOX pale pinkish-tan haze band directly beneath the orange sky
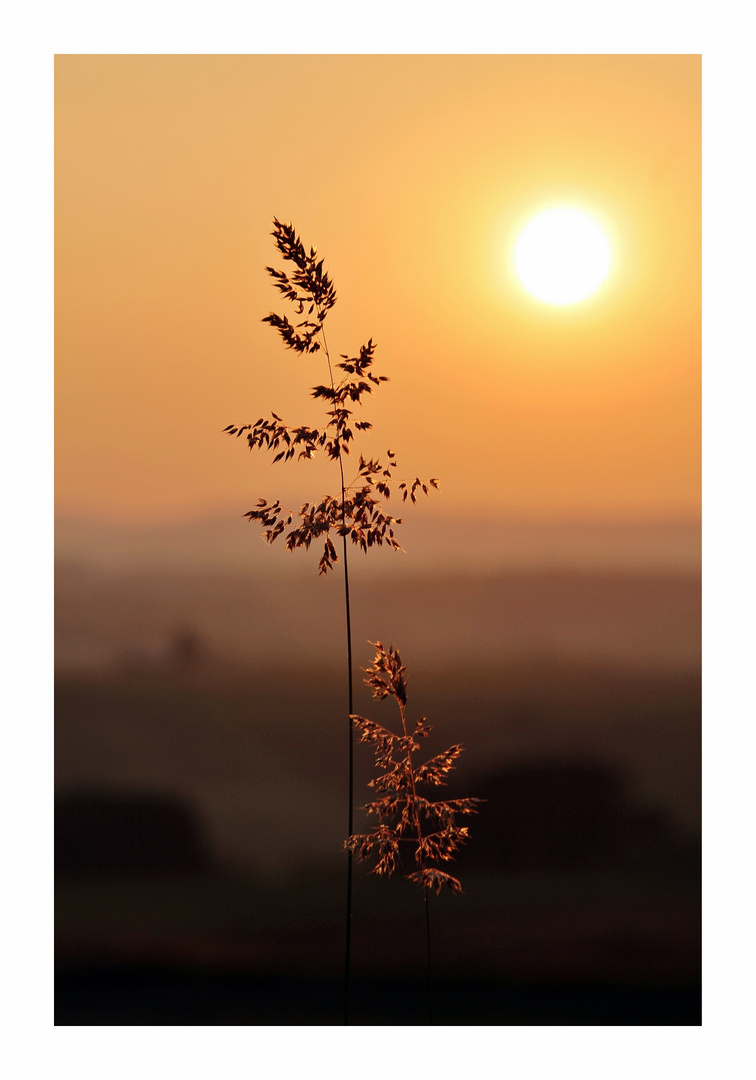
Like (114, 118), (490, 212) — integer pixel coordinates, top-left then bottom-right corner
(55, 509), (701, 578)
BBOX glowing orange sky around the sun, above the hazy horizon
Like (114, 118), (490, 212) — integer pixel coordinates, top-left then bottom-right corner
(55, 55), (701, 521)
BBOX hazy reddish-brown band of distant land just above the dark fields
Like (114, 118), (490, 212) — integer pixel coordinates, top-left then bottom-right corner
(55, 565), (701, 671)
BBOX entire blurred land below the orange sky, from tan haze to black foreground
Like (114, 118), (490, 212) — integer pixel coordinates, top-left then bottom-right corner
(55, 515), (701, 1025)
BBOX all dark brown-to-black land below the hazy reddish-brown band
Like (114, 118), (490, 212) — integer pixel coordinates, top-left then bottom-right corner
(55, 643), (701, 1026)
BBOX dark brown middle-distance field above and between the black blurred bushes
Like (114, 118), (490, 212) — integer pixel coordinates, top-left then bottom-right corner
(56, 662), (701, 873)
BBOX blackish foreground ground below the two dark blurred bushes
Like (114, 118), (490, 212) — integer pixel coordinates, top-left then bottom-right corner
(55, 856), (701, 1026)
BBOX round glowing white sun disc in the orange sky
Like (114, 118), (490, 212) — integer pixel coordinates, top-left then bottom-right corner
(514, 210), (611, 303)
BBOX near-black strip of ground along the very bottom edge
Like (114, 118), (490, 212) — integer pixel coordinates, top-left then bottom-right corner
(55, 967), (701, 1027)
